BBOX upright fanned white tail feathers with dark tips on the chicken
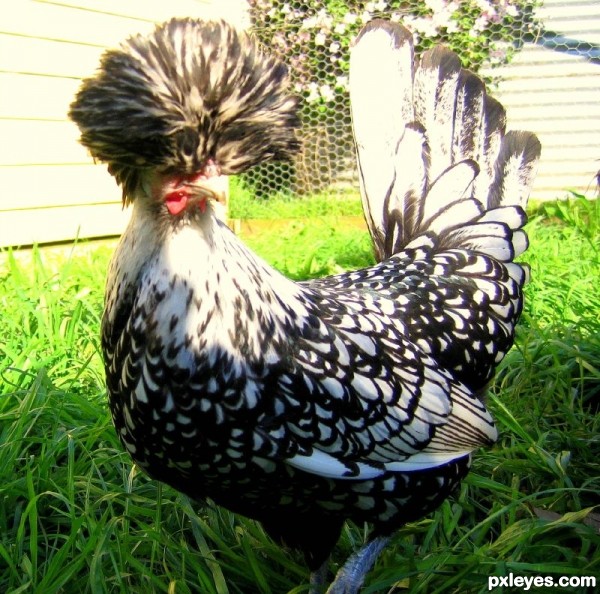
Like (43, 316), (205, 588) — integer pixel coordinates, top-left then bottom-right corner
(350, 21), (540, 261)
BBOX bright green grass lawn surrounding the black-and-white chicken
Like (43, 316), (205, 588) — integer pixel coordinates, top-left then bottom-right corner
(0, 192), (600, 594)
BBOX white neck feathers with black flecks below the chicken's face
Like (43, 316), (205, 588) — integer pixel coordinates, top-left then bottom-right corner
(106, 202), (308, 367)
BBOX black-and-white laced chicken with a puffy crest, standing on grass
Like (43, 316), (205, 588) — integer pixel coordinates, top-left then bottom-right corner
(70, 19), (540, 594)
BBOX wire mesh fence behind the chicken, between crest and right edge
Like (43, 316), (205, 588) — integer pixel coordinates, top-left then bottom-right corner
(243, 0), (600, 198)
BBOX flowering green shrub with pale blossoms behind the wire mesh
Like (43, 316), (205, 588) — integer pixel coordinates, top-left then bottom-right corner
(243, 0), (537, 198)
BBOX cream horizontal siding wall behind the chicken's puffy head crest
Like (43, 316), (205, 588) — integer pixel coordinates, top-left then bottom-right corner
(0, 0), (249, 247)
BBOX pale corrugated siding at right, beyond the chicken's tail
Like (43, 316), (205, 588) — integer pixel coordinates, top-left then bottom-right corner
(482, 0), (600, 200)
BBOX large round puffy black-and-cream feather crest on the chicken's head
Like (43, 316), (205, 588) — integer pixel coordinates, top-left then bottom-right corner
(69, 19), (299, 195)
